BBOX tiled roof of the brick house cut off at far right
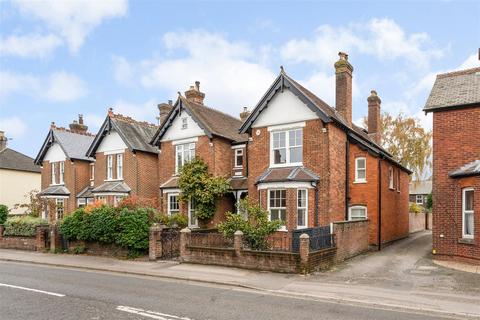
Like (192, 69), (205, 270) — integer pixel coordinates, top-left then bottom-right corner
(424, 68), (480, 112)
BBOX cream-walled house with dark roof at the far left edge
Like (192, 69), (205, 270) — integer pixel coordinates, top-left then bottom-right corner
(0, 131), (41, 214)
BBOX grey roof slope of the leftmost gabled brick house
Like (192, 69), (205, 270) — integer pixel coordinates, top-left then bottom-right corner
(35, 127), (95, 165)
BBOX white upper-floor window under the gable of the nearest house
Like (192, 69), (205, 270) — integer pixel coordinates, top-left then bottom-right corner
(270, 128), (303, 166)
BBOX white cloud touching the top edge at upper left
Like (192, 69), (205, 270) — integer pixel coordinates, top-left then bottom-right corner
(14, 0), (127, 52)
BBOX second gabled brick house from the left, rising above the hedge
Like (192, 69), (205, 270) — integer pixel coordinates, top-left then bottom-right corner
(86, 108), (158, 205)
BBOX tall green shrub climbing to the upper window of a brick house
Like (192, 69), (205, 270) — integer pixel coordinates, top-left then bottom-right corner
(178, 158), (230, 220)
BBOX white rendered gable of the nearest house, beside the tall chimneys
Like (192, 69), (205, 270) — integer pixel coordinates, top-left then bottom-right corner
(252, 89), (318, 128)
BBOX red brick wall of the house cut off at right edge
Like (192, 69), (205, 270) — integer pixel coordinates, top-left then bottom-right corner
(433, 106), (480, 263)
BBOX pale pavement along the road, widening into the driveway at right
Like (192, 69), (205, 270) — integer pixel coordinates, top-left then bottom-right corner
(0, 232), (480, 319)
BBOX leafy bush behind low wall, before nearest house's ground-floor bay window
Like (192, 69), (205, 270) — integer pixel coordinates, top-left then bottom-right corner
(217, 197), (282, 250)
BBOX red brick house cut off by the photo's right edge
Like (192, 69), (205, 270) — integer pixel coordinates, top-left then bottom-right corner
(424, 68), (480, 264)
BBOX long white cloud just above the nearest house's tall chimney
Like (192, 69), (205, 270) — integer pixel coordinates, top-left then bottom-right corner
(281, 18), (443, 68)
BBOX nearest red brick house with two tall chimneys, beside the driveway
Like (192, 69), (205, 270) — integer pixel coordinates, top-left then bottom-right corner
(240, 53), (411, 245)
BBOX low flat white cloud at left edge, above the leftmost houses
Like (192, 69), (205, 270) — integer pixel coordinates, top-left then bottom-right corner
(0, 71), (88, 102)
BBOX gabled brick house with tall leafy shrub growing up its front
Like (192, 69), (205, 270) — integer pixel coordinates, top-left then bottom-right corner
(151, 81), (248, 227)
